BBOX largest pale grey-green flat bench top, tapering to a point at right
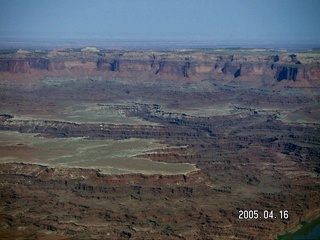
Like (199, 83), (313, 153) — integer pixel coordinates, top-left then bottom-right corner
(0, 131), (197, 175)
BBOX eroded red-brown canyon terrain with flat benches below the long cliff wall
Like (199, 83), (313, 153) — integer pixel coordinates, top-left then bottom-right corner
(0, 48), (320, 239)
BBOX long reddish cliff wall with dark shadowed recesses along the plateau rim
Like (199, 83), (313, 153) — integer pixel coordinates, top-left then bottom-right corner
(0, 52), (320, 87)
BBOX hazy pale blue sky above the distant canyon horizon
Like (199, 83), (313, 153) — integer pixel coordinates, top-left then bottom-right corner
(0, 0), (320, 42)
